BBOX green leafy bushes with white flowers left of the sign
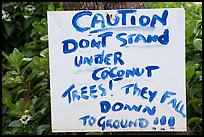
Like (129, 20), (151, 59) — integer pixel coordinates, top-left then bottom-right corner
(2, 2), (62, 135)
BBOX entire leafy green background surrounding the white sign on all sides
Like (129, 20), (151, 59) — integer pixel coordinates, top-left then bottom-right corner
(2, 2), (202, 135)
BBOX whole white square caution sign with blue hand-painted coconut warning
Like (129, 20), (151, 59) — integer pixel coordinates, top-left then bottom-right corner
(48, 8), (187, 132)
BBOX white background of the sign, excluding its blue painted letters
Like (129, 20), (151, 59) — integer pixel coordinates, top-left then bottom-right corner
(48, 8), (186, 132)
